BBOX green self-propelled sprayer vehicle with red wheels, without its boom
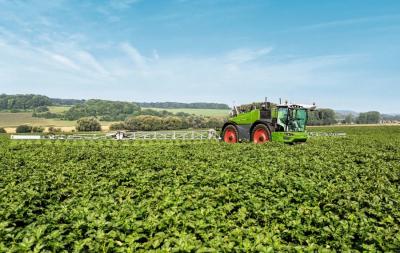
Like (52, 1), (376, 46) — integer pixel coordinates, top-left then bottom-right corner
(221, 102), (315, 143)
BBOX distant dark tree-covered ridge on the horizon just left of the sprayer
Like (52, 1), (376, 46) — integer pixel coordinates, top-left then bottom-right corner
(138, 102), (230, 110)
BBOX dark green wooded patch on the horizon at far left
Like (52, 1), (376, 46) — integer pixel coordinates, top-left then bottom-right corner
(0, 94), (52, 112)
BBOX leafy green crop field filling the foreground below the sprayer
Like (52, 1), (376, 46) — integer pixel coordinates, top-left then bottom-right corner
(0, 126), (400, 252)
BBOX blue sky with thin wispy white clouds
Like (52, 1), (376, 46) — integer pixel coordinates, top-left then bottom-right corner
(0, 0), (400, 113)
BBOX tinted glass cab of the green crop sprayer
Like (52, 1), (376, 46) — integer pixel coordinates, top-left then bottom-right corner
(278, 108), (307, 132)
